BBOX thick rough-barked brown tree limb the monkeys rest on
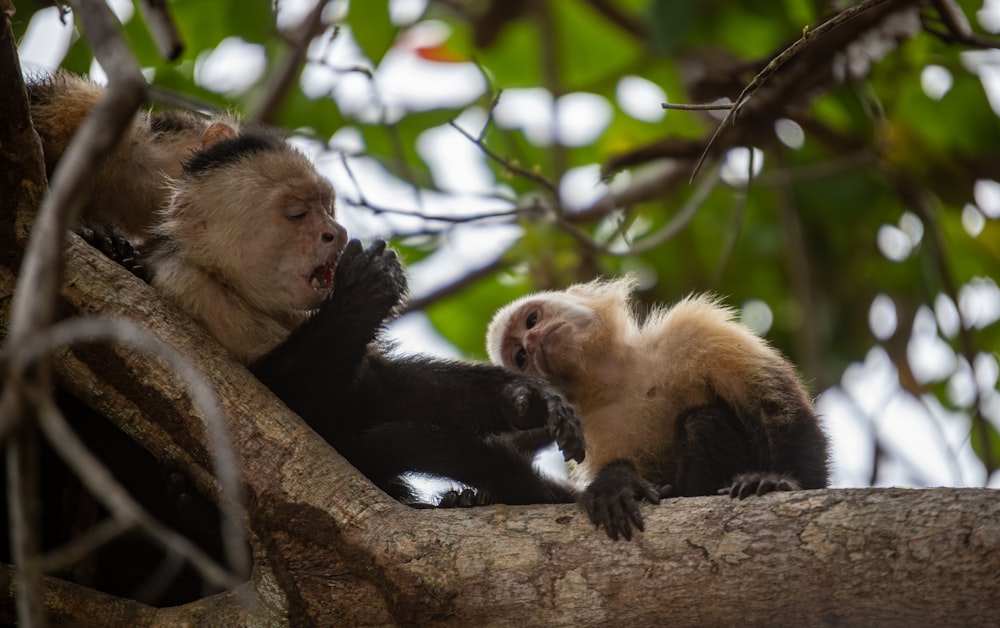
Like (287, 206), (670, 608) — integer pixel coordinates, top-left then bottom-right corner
(0, 238), (1000, 625)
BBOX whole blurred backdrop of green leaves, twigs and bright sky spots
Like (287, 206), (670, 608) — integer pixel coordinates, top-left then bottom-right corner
(13, 0), (1000, 486)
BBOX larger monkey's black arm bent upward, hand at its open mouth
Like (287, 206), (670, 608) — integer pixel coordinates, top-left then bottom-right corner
(251, 240), (406, 420)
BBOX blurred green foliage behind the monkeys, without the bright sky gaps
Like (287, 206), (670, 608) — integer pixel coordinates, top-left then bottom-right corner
(15, 0), (1000, 484)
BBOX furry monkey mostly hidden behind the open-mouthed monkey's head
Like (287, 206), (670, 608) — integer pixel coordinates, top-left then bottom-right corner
(27, 70), (240, 239)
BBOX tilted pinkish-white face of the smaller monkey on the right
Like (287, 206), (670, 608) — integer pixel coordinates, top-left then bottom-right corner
(499, 293), (600, 394)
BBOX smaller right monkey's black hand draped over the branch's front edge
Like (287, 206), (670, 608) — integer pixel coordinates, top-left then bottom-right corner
(580, 460), (672, 541)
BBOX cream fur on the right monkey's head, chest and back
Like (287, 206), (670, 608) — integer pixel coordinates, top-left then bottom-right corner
(487, 278), (805, 483)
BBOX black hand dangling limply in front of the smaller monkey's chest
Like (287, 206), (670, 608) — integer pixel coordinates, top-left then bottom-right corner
(504, 378), (585, 462)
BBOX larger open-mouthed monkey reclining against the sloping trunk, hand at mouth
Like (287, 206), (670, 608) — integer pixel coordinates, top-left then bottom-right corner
(81, 131), (583, 506)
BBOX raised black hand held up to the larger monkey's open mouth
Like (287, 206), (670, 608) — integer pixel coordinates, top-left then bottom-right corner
(320, 240), (406, 327)
